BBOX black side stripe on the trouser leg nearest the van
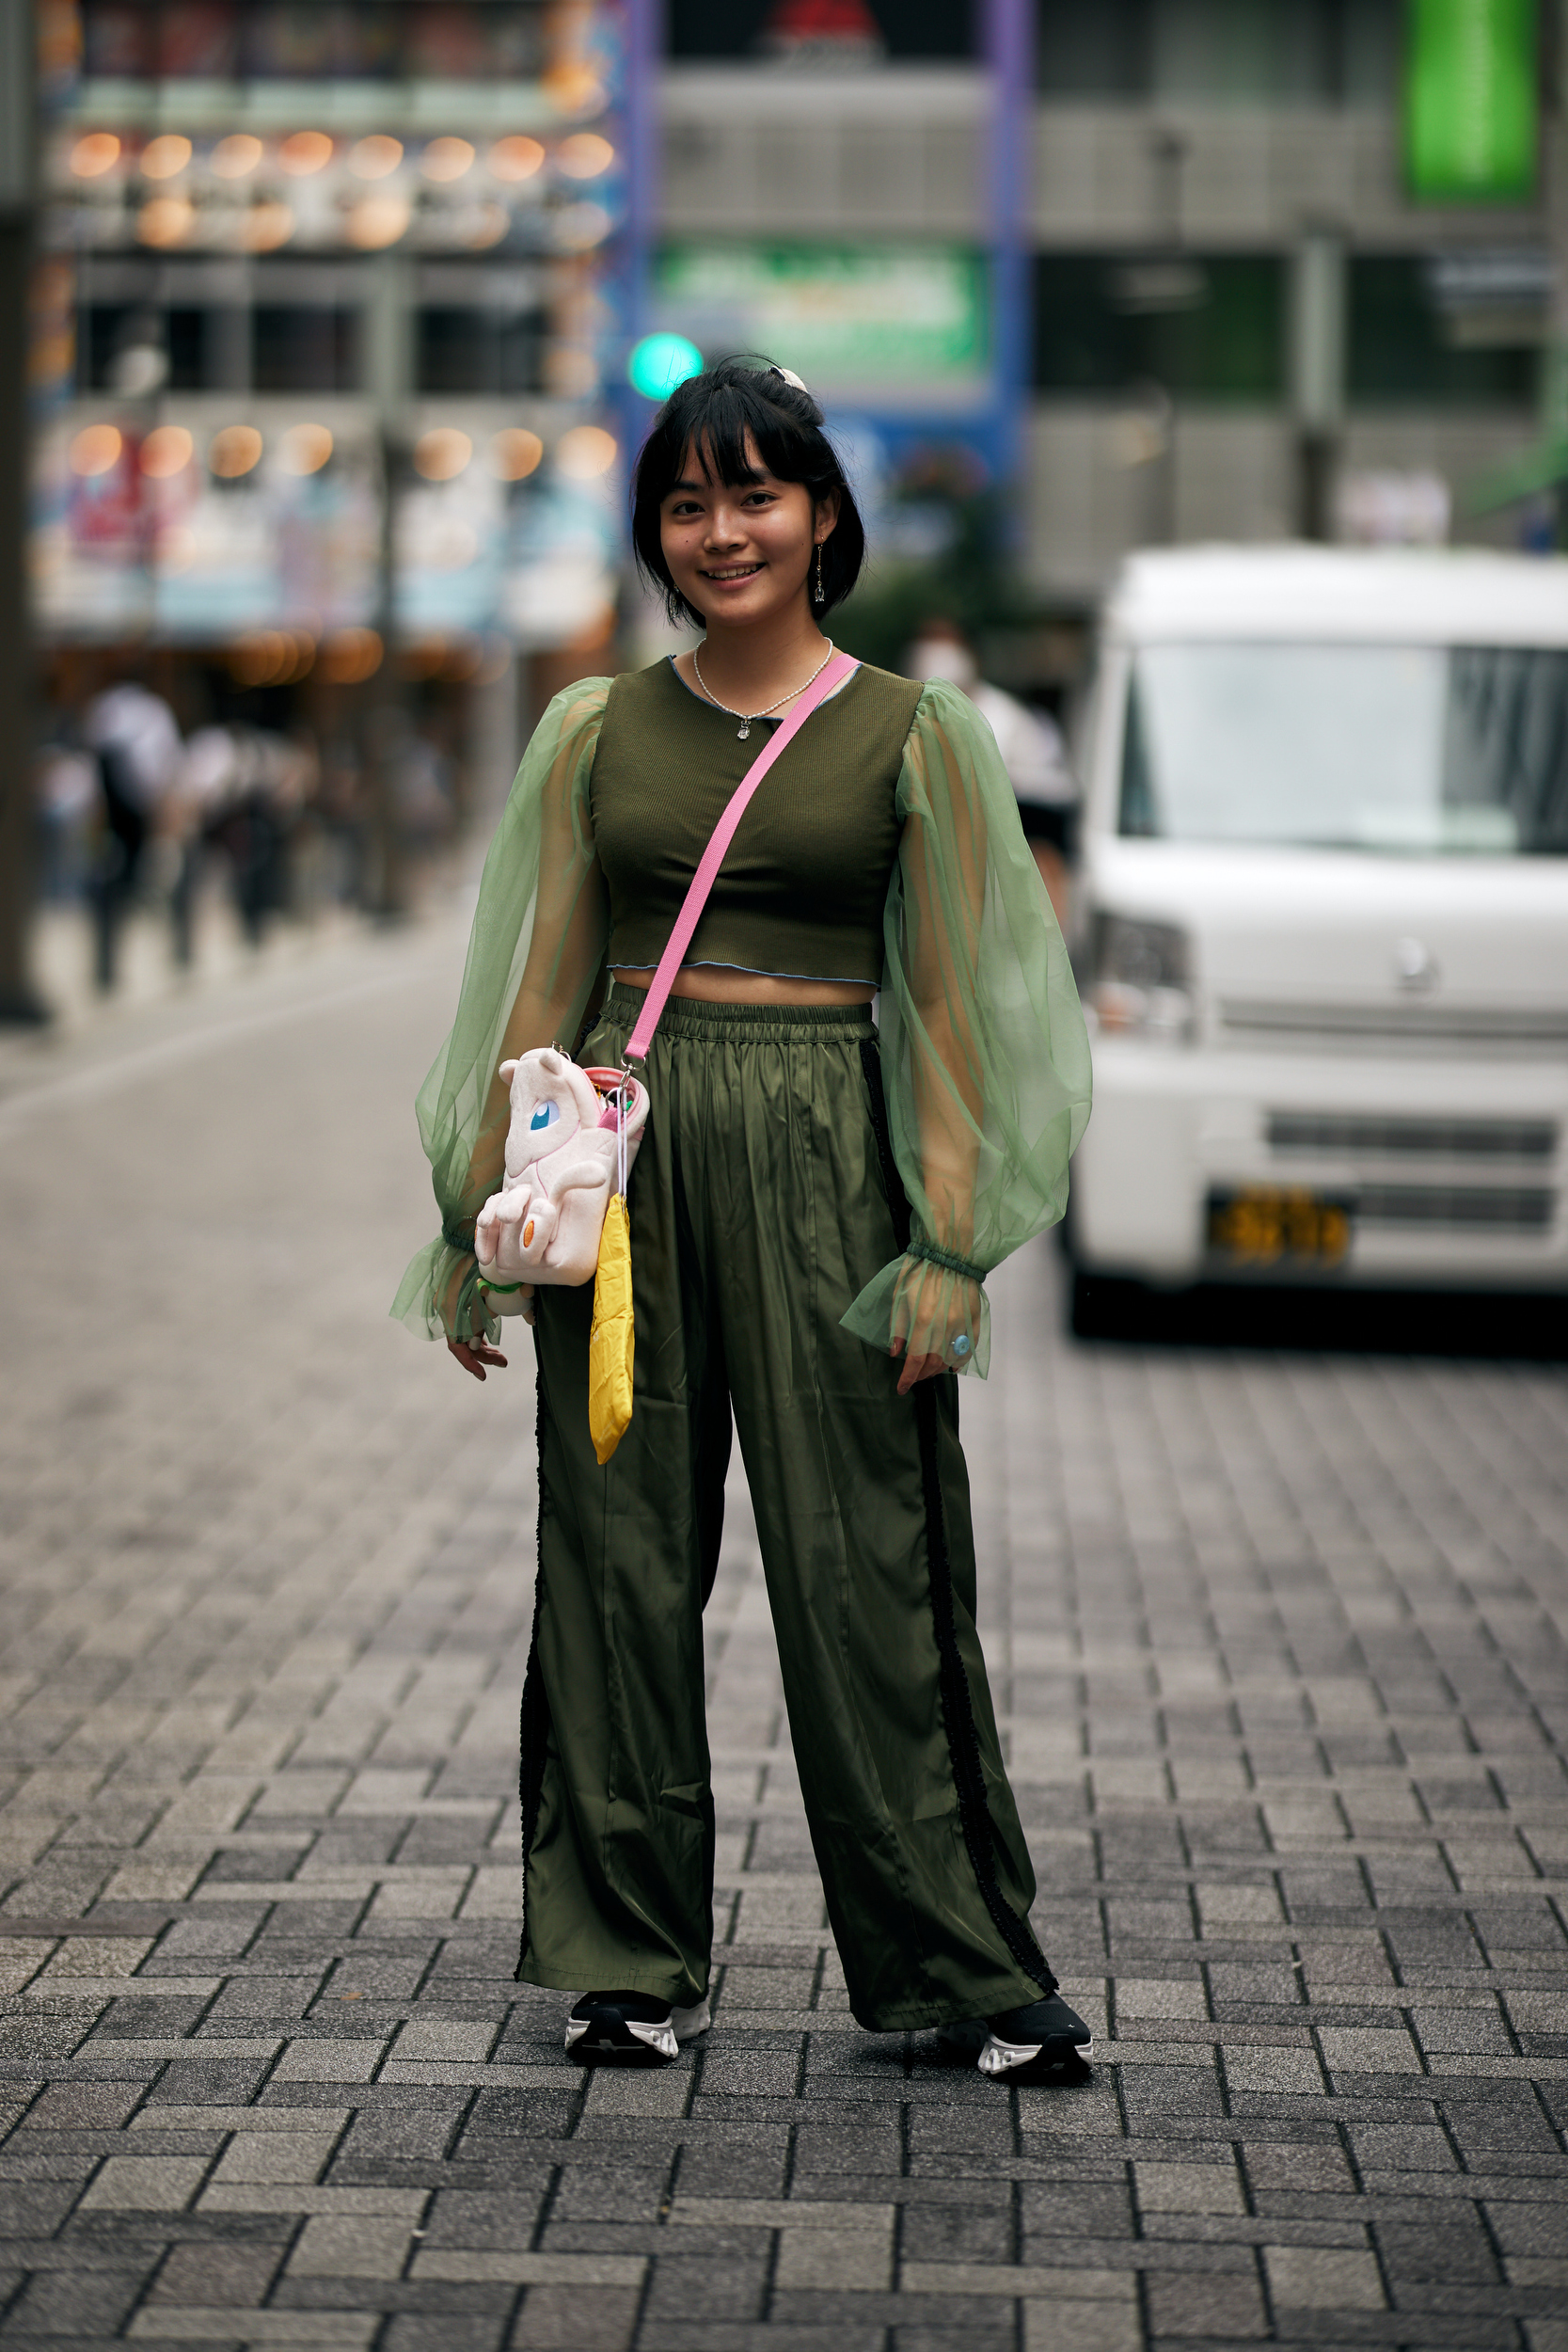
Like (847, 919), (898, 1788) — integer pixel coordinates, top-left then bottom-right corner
(861, 1038), (1055, 1994)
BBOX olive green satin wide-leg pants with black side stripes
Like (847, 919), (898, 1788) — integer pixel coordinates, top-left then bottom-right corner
(517, 988), (1055, 2030)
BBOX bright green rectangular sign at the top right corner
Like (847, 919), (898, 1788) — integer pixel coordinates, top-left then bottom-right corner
(1403, 0), (1538, 205)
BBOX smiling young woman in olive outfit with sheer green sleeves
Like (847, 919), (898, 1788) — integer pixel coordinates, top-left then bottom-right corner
(392, 360), (1088, 2074)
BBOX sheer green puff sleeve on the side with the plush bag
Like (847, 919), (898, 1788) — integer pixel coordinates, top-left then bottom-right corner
(392, 677), (609, 1339)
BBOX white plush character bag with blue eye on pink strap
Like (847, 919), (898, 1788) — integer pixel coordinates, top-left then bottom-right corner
(472, 1047), (649, 1282)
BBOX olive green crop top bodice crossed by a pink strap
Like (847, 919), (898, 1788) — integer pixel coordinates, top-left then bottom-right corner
(588, 661), (922, 988)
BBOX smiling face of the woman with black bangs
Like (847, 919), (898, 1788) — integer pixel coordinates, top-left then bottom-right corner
(658, 433), (839, 628)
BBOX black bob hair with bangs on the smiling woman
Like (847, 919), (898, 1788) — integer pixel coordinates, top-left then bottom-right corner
(632, 360), (865, 628)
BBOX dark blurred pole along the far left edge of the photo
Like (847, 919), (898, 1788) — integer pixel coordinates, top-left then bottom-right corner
(0, 0), (47, 1024)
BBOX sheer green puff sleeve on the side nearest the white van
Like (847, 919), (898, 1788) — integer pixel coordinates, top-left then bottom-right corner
(844, 682), (1088, 1376)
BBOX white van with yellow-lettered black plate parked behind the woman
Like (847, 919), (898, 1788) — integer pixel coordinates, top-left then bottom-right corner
(1068, 548), (1568, 1329)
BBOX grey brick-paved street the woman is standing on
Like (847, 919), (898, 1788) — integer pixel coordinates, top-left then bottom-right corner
(0, 939), (1568, 2352)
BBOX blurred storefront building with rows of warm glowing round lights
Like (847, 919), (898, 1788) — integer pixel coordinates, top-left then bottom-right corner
(33, 0), (649, 931)
